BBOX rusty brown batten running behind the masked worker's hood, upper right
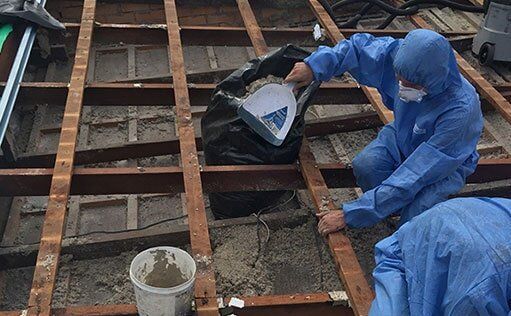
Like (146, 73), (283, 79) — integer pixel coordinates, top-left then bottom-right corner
(409, 14), (511, 123)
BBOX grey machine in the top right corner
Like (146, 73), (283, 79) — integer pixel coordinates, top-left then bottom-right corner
(472, 0), (511, 65)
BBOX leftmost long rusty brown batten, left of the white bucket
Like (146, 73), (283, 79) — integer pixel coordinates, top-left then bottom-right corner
(28, 0), (96, 315)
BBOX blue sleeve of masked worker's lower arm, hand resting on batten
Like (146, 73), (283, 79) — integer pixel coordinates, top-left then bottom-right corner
(342, 108), (477, 227)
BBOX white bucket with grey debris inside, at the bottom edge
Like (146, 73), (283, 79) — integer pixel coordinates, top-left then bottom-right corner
(130, 247), (197, 316)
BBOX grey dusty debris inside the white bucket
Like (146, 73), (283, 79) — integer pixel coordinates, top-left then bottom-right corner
(142, 249), (188, 288)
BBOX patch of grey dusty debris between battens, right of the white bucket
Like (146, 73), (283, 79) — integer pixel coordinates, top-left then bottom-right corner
(211, 216), (342, 296)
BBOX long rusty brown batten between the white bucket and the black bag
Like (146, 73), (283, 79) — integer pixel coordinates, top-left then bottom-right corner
(164, 0), (218, 315)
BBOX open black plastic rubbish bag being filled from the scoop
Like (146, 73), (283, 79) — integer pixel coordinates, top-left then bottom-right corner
(201, 45), (320, 219)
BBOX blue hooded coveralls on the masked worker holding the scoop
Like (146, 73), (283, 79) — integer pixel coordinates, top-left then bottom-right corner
(305, 30), (483, 227)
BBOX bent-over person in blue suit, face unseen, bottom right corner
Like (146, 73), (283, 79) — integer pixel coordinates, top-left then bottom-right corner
(369, 198), (511, 316)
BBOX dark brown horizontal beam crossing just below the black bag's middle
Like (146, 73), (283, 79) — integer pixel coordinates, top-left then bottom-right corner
(0, 159), (511, 196)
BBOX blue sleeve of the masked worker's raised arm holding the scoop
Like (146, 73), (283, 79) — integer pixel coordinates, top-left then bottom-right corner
(305, 33), (401, 106)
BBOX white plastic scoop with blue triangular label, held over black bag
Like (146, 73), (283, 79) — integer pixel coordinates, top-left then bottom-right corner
(238, 82), (296, 146)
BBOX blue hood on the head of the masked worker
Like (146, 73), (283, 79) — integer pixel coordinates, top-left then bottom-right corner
(394, 29), (461, 96)
